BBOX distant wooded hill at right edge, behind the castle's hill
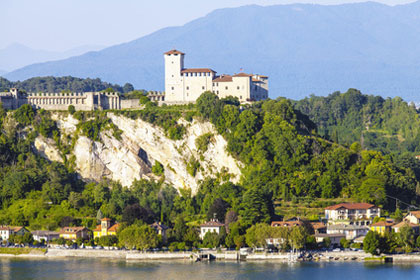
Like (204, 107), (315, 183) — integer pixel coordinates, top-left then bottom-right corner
(296, 89), (420, 154)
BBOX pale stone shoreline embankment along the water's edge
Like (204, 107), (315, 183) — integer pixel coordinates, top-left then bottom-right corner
(0, 248), (420, 263)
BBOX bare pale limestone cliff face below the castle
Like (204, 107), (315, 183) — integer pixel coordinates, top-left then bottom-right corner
(35, 113), (241, 193)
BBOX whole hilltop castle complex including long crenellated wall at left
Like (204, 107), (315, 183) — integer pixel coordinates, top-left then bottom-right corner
(0, 50), (268, 111)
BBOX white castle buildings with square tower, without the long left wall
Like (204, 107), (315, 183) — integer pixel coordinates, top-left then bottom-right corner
(164, 50), (268, 103)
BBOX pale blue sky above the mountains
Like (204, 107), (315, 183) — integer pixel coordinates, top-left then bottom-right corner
(0, 0), (414, 51)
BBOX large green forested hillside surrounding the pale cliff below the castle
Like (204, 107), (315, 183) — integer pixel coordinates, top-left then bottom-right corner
(0, 92), (420, 247)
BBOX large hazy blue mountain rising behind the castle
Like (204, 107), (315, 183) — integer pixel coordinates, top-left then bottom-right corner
(4, 1), (420, 101)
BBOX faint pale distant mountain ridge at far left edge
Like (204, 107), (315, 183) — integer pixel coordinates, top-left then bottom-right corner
(0, 43), (105, 72)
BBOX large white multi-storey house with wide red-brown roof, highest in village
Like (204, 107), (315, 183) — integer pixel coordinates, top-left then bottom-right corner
(325, 203), (381, 226)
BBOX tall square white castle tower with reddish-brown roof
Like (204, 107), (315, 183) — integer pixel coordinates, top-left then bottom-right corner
(164, 50), (185, 101)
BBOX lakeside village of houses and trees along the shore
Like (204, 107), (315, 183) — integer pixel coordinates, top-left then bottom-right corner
(0, 203), (420, 256)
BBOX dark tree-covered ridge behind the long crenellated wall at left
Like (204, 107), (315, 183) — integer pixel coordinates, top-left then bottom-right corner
(0, 76), (134, 93)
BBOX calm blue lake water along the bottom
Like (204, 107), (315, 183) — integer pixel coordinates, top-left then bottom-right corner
(0, 258), (420, 280)
